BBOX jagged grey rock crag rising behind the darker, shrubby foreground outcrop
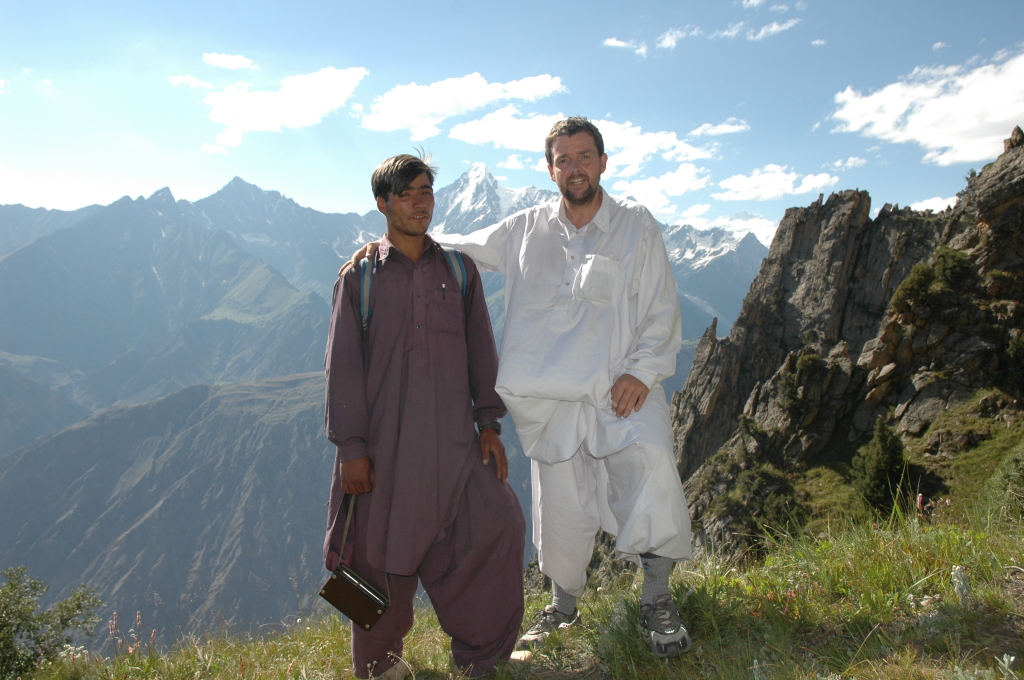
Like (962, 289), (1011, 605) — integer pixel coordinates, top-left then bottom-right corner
(672, 190), (943, 480)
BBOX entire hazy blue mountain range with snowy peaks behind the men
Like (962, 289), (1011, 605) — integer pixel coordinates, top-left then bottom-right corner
(0, 165), (767, 644)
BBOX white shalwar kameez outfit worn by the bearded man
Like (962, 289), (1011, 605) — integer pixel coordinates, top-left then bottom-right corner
(434, 189), (691, 597)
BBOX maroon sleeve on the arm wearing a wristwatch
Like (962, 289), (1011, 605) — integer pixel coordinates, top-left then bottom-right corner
(460, 255), (506, 426)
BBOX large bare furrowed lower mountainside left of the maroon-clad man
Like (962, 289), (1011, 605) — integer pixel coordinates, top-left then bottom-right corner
(0, 373), (528, 644)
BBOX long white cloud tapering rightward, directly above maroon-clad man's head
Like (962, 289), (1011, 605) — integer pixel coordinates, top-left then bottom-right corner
(362, 73), (565, 141)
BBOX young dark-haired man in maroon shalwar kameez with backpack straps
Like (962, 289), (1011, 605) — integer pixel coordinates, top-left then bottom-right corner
(324, 156), (525, 679)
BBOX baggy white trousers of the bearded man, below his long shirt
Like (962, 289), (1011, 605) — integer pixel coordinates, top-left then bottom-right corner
(531, 385), (693, 597)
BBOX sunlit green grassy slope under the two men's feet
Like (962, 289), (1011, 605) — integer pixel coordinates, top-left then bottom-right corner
(28, 394), (1024, 680)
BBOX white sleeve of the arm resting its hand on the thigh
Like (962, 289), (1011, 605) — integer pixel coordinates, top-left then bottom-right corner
(625, 213), (683, 387)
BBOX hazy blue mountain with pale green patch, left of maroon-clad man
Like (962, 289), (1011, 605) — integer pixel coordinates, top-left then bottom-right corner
(0, 189), (329, 408)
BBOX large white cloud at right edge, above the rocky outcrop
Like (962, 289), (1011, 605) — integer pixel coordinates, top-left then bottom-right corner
(833, 53), (1024, 165)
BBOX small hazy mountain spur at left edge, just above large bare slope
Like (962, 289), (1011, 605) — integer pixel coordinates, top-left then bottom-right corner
(0, 366), (89, 458)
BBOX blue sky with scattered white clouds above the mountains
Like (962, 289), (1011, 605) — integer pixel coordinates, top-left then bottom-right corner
(0, 0), (1024, 243)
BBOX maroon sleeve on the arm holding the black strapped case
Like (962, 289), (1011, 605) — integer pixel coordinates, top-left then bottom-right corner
(324, 266), (370, 462)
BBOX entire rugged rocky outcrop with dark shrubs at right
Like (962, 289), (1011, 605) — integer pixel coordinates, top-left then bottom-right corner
(672, 128), (1024, 549)
